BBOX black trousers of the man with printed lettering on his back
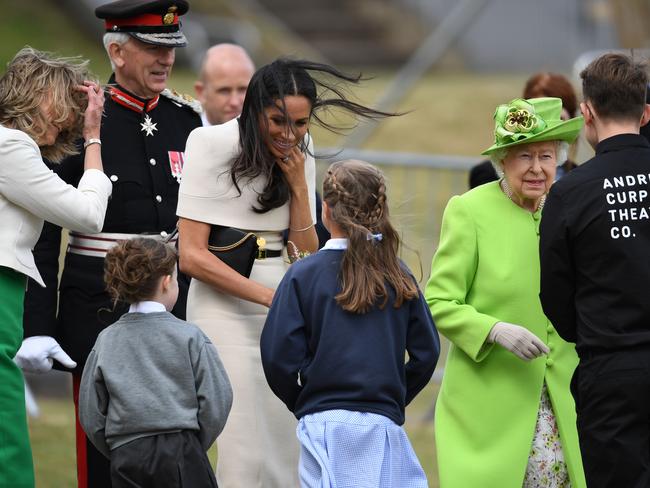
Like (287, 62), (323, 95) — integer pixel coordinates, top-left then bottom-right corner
(571, 346), (650, 488)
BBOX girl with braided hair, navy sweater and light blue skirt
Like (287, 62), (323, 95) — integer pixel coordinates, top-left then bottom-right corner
(261, 160), (440, 488)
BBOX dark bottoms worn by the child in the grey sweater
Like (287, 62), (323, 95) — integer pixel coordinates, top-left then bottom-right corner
(111, 430), (217, 488)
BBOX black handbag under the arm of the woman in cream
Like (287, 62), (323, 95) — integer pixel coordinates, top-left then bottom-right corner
(208, 225), (259, 278)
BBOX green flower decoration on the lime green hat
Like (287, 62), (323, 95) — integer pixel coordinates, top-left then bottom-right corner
(494, 98), (546, 145)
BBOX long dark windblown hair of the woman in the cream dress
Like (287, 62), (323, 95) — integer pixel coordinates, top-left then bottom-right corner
(230, 58), (397, 213)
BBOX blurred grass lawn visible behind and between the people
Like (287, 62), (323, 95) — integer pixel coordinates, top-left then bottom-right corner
(10, 0), (584, 488)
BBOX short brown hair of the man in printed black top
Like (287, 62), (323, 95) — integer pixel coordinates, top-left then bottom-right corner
(580, 53), (648, 121)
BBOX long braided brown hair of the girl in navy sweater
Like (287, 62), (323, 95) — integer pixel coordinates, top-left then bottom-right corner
(323, 160), (418, 313)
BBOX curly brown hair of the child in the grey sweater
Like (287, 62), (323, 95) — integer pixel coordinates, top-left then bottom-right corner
(104, 237), (178, 305)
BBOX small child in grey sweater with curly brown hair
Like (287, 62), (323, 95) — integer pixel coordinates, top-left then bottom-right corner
(79, 238), (232, 488)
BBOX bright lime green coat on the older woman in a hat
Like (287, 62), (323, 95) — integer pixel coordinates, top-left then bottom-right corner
(425, 182), (586, 488)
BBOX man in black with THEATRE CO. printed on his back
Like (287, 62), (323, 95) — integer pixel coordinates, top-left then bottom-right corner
(540, 54), (650, 488)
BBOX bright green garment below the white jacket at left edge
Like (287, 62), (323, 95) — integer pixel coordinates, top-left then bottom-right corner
(0, 266), (34, 488)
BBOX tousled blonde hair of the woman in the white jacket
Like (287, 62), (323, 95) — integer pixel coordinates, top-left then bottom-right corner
(0, 46), (91, 163)
